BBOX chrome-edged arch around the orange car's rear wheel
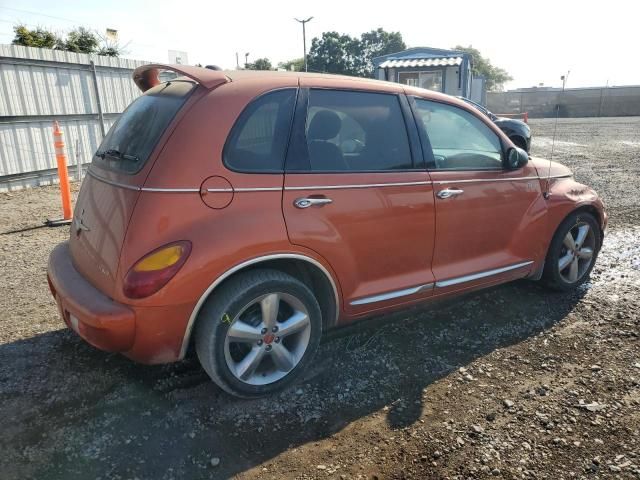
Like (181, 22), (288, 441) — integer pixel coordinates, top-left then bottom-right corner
(179, 253), (340, 359)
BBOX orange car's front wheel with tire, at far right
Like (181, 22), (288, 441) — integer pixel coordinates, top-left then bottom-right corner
(542, 212), (602, 291)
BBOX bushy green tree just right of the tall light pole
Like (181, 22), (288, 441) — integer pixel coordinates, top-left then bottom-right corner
(307, 32), (362, 76)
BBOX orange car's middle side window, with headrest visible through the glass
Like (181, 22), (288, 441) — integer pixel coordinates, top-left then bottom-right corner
(305, 89), (413, 172)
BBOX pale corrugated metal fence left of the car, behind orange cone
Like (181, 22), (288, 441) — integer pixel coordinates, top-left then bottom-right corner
(0, 45), (149, 191)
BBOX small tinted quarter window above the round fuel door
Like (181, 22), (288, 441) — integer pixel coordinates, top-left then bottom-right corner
(223, 88), (296, 172)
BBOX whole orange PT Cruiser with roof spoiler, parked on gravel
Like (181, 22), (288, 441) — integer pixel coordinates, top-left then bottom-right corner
(48, 65), (607, 397)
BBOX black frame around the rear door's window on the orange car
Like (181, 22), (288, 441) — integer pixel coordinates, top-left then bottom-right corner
(284, 86), (426, 175)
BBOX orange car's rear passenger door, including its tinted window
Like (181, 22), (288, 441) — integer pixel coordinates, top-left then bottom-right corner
(283, 88), (434, 315)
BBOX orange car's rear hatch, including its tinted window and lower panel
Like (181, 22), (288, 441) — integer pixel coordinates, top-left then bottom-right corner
(70, 79), (197, 298)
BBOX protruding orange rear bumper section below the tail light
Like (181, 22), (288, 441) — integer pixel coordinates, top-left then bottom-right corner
(47, 242), (135, 352)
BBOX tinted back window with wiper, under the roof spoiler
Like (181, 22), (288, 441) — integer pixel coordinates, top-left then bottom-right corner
(93, 80), (196, 173)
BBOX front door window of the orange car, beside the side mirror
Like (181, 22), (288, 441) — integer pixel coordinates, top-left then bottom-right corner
(416, 99), (502, 170)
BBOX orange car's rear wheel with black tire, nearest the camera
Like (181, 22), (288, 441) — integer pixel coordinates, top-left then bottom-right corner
(195, 269), (322, 398)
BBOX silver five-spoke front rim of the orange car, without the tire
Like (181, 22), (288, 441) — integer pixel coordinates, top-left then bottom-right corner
(558, 222), (596, 283)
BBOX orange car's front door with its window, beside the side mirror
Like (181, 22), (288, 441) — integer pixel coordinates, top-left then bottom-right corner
(411, 98), (545, 295)
